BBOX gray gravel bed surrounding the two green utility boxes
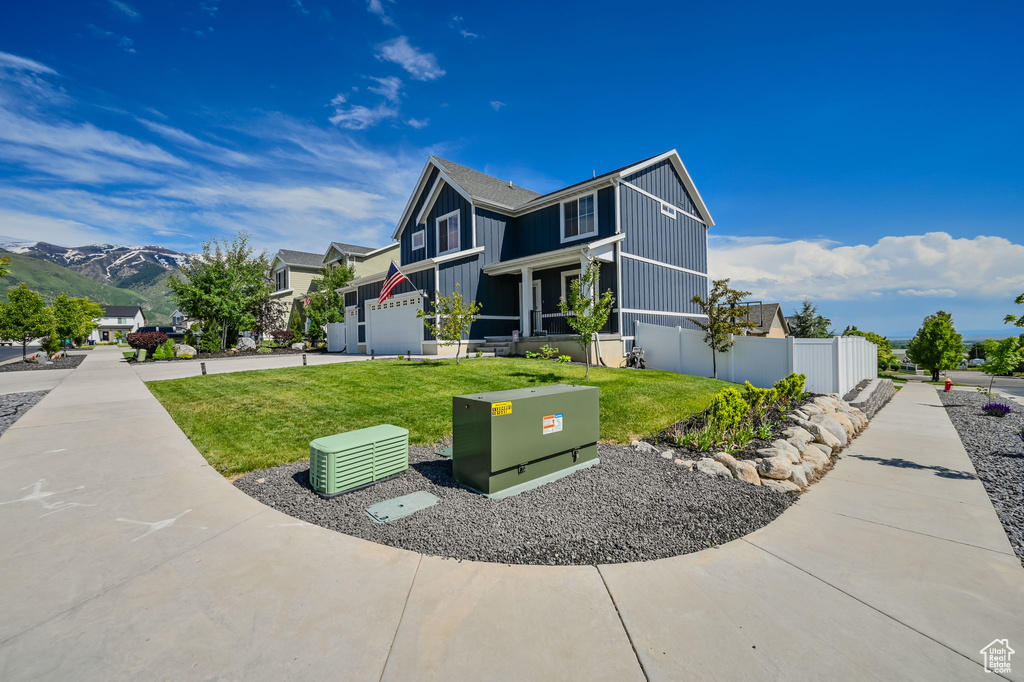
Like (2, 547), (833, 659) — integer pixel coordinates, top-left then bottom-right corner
(236, 444), (794, 565)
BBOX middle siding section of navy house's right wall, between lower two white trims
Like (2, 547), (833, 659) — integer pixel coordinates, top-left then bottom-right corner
(622, 258), (708, 312)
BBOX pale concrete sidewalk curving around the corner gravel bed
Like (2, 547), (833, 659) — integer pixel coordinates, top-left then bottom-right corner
(0, 348), (1024, 680)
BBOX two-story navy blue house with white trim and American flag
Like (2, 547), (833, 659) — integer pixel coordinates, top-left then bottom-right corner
(343, 151), (714, 356)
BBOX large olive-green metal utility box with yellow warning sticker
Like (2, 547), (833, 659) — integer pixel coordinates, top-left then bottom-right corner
(452, 384), (601, 498)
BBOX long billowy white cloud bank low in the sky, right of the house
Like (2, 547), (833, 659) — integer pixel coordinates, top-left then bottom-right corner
(709, 232), (1024, 301)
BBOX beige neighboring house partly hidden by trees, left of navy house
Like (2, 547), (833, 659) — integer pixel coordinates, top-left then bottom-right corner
(270, 242), (398, 327)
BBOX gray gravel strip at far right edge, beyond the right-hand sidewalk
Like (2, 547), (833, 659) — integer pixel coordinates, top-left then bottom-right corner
(939, 391), (1024, 564)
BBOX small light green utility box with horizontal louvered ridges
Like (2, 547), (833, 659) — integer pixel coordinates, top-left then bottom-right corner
(309, 424), (409, 498)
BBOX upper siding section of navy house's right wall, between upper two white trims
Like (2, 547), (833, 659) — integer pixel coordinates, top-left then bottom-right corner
(620, 187), (708, 272)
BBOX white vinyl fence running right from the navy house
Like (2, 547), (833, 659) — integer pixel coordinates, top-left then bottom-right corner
(635, 323), (879, 395)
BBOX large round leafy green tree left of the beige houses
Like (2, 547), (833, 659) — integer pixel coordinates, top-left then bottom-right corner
(167, 232), (271, 349)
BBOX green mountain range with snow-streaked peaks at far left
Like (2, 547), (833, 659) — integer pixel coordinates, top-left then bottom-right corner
(0, 237), (188, 324)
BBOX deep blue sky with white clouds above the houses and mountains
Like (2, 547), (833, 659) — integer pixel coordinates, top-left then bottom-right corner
(0, 0), (1024, 335)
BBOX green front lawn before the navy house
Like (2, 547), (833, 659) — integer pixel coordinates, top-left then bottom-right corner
(147, 357), (731, 475)
